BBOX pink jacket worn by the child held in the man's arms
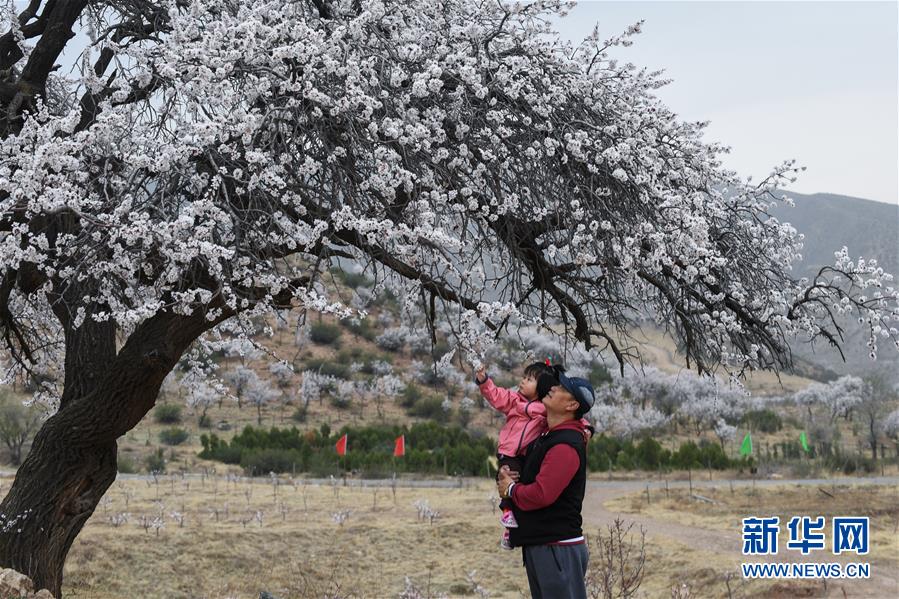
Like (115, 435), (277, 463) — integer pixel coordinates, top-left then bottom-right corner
(478, 377), (546, 456)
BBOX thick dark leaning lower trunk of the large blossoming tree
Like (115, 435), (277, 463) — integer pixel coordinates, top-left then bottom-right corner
(0, 313), (228, 597)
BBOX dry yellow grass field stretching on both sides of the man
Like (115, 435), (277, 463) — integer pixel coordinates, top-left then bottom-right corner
(0, 475), (899, 599)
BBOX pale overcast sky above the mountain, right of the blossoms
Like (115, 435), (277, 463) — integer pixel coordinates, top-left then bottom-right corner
(559, 0), (899, 204)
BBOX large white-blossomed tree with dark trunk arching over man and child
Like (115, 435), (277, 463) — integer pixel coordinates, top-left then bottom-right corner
(0, 0), (899, 594)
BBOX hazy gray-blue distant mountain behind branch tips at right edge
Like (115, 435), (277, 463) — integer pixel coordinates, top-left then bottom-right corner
(772, 192), (899, 374)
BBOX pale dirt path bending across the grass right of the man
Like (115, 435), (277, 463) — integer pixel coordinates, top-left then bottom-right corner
(583, 477), (899, 599)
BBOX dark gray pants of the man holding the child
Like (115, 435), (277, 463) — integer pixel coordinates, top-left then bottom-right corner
(523, 543), (587, 599)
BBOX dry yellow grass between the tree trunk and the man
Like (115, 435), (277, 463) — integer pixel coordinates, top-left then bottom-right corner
(51, 476), (526, 599)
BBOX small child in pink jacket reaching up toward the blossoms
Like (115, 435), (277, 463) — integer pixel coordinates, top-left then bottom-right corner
(475, 360), (592, 549)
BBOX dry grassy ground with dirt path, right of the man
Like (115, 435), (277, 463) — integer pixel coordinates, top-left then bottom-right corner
(603, 481), (899, 599)
